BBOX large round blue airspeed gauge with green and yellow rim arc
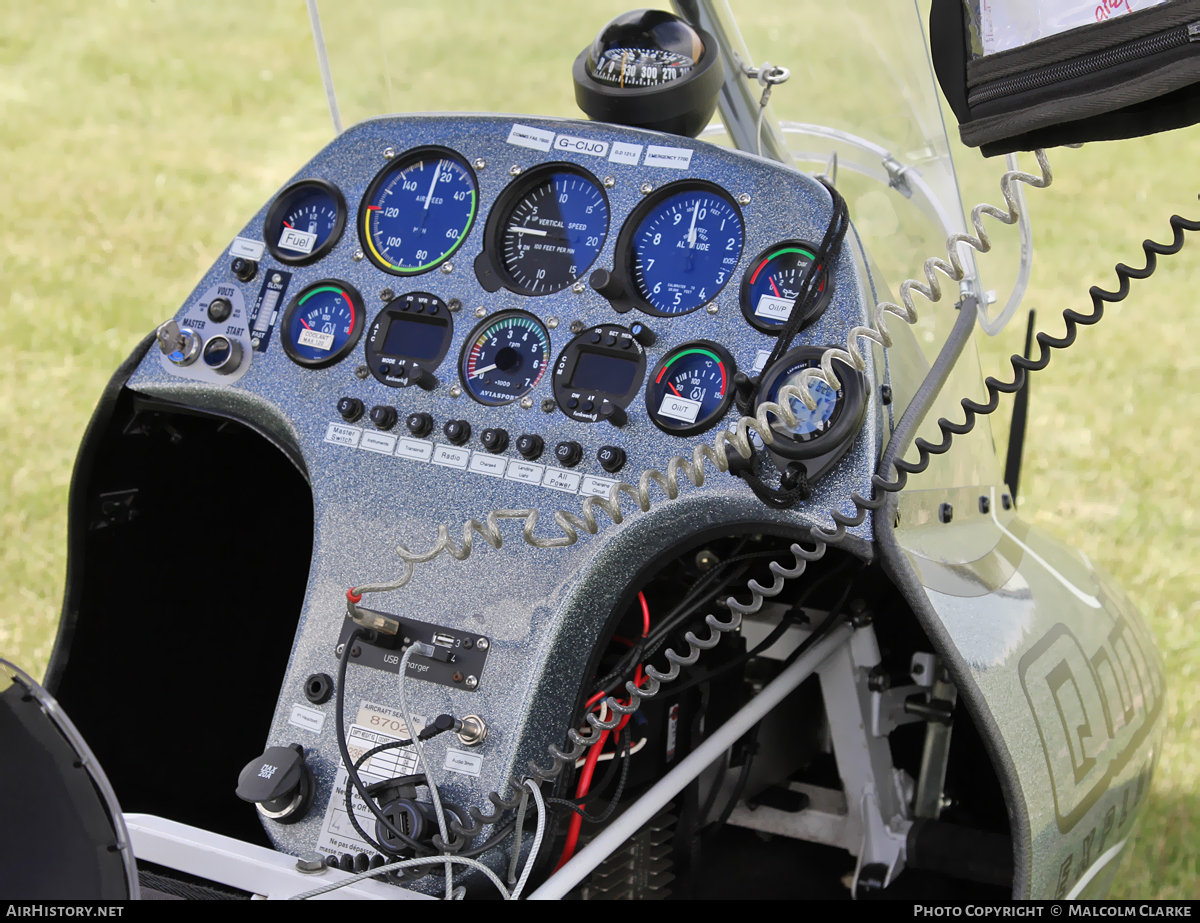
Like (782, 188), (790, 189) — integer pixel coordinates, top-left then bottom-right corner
(359, 148), (479, 276)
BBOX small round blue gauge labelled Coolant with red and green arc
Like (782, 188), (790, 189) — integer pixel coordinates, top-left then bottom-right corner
(280, 278), (365, 368)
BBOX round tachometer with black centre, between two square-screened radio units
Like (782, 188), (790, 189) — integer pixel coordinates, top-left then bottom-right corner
(458, 311), (550, 407)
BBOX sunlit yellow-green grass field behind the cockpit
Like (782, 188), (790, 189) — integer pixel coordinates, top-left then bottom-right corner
(0, 0), (1200, 898)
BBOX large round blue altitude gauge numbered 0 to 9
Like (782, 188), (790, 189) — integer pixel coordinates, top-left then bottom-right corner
(618, 180), (744, 316)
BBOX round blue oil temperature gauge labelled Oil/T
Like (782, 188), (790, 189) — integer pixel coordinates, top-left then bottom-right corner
(646, 340), (737, 436)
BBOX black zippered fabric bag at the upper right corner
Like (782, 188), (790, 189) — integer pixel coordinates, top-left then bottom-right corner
(929, 0), (1200, 157)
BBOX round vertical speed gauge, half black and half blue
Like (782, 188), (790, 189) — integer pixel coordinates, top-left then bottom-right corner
(485, 163), (608, 295)
